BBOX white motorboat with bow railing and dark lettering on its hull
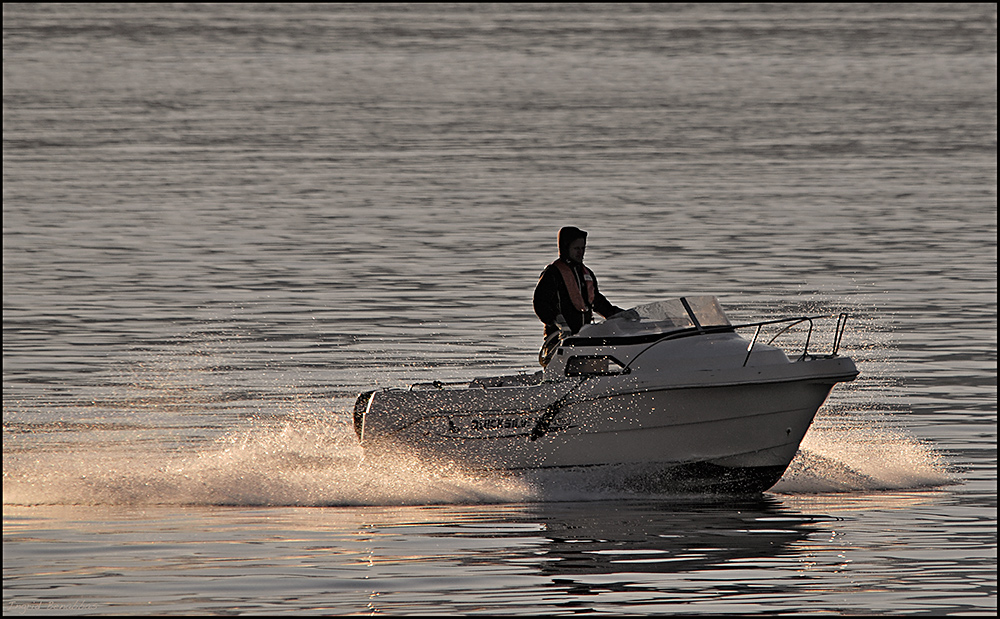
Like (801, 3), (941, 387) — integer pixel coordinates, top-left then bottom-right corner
(354, 296), (858, 494)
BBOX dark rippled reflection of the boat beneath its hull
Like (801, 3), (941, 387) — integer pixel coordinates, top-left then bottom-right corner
(467, 496), (837, 577)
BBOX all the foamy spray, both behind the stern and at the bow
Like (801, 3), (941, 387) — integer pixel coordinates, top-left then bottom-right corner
(3, 410), (954, 506)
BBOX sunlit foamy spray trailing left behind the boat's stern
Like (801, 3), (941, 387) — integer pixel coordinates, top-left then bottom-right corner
(3, 420), (540, 506)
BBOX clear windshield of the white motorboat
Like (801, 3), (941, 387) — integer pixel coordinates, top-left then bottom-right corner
(578, 296), (730, 338)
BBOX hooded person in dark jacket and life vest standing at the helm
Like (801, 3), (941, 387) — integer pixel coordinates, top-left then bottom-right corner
(533, 226), (623, 352)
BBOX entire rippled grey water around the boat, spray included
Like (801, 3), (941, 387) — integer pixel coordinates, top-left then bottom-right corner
(3, 3), (997, 616)
